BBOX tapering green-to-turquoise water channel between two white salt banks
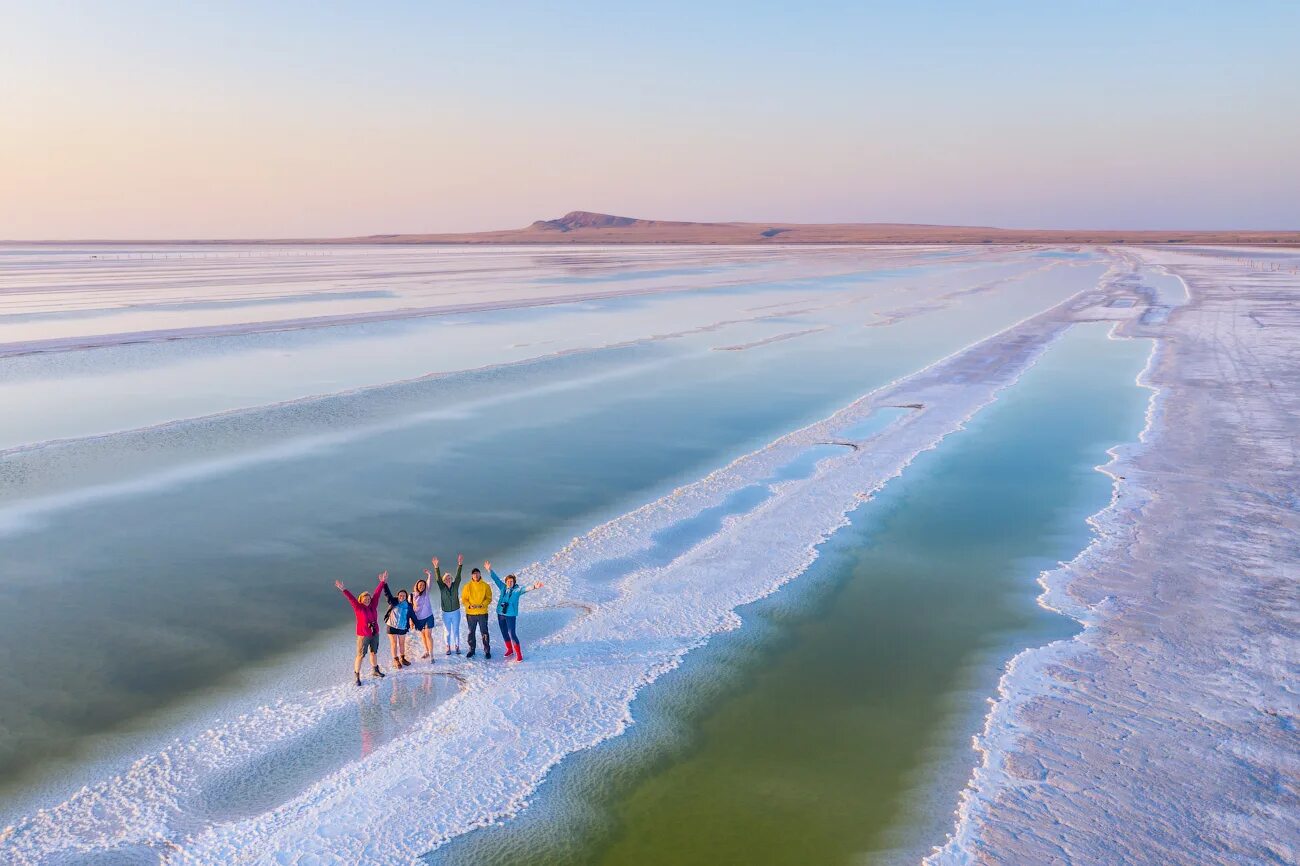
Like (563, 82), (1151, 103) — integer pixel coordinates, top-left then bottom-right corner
(433, 319), (1149, 863)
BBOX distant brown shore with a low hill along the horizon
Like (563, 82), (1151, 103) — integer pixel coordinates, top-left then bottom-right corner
(0, 211), (1300, 246)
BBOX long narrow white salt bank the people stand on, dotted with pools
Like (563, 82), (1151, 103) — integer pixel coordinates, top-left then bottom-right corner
(0, 253), (1128, 863)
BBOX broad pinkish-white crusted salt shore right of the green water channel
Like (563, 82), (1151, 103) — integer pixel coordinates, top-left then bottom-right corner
(927, 244), (1300, 866)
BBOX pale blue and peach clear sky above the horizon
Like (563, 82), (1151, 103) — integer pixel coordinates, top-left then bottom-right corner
(0, 0), (1300, 239)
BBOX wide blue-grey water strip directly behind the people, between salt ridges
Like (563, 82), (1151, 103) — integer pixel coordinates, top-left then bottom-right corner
(0, 250), (1100, 802)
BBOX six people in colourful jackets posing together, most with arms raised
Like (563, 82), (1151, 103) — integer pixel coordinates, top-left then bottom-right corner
(334, 555), (542, 685)
